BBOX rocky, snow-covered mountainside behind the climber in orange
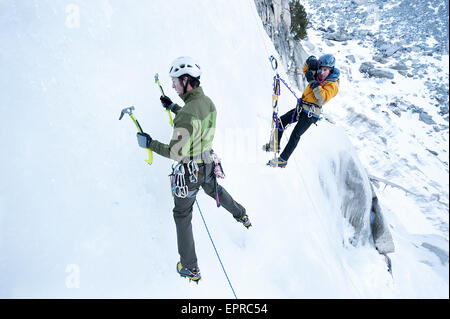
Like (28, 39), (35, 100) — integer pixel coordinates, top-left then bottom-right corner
(304, 0), (449, 232)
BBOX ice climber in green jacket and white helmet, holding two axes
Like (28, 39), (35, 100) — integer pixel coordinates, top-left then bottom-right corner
(137, 57), (251, 282)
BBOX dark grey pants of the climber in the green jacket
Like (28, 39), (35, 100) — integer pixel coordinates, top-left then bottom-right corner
(173, 163), (245, 268)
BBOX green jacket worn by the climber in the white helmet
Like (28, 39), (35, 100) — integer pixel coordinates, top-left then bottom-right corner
(150, 87), (216, 162)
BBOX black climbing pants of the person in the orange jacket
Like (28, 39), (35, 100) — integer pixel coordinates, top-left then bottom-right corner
(278, 108), (318, 161)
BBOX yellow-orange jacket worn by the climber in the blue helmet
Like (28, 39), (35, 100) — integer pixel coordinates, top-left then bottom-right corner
(302, 63), (341, 115)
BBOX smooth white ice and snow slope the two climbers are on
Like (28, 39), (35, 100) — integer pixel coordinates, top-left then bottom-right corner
(0, 0), (448, 298)
